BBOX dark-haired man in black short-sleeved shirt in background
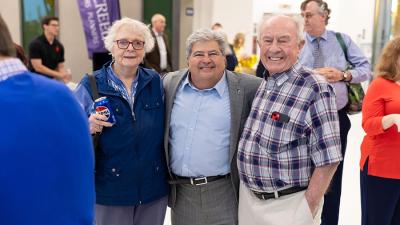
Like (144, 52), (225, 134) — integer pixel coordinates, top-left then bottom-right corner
(29, 16), (71, 83)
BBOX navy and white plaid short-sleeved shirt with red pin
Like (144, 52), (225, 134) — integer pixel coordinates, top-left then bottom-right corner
(238, 63), (342, 192)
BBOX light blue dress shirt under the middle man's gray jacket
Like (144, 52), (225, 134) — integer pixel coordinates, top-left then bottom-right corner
(169, 74), (231, 177)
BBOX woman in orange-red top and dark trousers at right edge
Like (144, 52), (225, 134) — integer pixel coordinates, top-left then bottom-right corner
(360, 37), (400, 225)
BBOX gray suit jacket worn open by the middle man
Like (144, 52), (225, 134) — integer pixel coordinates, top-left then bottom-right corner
(163, 69), (262, 208)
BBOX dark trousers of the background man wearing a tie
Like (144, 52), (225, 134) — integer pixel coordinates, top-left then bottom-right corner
(321, 109), (351, 225)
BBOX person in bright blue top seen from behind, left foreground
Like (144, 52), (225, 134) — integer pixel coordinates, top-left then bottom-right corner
(0, 16), (94, 225)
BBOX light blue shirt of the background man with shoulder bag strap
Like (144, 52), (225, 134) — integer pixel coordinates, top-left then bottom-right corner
(299, 30), (371, 109)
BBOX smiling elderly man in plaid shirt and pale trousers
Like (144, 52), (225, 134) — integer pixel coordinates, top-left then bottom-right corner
(238, 15), (342, 225)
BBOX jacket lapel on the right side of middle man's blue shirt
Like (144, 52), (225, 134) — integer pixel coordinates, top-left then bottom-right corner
(226, 70), (244, 162)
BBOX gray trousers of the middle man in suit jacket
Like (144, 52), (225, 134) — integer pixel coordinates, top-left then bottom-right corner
(171, 178), (238, 225)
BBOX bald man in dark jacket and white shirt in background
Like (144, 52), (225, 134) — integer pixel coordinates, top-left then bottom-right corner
(144, 13), (172, 74)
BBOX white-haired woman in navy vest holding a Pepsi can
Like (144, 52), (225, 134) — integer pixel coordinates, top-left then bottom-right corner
(75, 18), (169, 225)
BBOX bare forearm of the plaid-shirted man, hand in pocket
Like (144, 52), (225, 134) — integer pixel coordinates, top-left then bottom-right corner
(305, 162), (339, 216)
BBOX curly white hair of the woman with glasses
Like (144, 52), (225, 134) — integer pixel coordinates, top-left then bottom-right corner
(104, 17), (154, 52)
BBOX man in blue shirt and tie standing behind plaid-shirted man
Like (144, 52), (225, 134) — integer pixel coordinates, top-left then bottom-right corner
(299, 0), (371, 225)
